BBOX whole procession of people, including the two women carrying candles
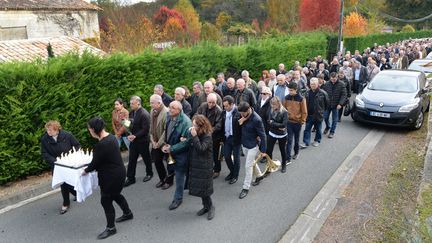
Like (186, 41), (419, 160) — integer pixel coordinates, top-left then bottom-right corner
(42, 39), (432, 239)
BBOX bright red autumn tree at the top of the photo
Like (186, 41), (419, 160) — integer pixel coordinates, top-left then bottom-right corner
(300, 0), (341, 31)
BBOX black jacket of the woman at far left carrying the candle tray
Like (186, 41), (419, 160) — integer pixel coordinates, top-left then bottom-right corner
(41, 130), (80, 169)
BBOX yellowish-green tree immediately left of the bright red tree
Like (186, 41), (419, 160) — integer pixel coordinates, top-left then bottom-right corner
(267, 0), (300, 31)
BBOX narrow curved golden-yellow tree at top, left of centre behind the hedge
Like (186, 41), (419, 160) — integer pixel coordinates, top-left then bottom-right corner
(174, 0), (201, 43)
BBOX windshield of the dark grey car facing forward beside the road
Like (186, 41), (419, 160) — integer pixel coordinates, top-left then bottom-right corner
(368, 75), (417, 93)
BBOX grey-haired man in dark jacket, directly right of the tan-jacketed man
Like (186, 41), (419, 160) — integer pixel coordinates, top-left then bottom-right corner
(300, 78), (329, 149)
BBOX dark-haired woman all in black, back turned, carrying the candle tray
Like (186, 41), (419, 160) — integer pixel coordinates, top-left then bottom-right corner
(82, 117), (133, 239)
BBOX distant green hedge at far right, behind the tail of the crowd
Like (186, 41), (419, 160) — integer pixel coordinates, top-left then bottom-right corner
(344, 30), (432, 53)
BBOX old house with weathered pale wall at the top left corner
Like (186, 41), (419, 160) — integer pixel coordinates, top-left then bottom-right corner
(0, 0), (101, 41)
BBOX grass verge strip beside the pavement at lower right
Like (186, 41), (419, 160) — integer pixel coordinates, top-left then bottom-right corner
(362, 116), (432, 242)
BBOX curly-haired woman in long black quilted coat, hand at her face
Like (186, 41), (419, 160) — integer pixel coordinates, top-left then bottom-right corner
(189, 115), (215, 220)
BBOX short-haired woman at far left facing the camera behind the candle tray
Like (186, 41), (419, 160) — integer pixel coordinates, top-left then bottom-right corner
(41, 121), (80, 214)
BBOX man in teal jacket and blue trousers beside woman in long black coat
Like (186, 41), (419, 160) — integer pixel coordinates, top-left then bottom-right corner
(162, 101), (192, 210)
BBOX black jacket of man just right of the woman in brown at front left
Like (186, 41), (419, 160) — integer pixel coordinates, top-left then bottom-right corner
(129, 107), (150, 143)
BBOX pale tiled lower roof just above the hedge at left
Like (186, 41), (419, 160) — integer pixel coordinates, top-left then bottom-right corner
(0, 36), (106, 63)
